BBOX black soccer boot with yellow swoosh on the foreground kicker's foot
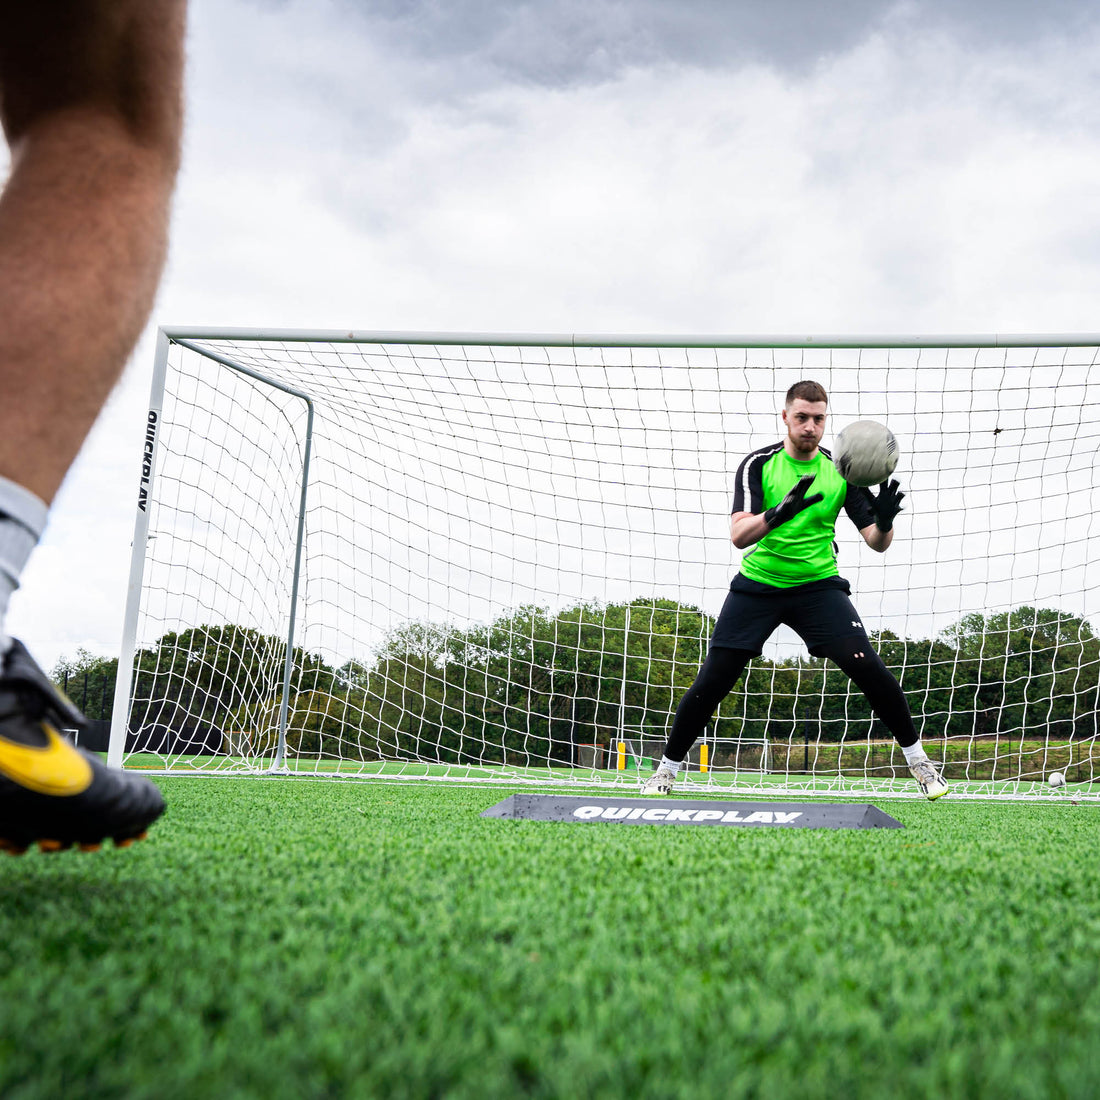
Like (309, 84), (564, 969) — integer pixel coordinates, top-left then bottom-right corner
(0, 640), (164, 854)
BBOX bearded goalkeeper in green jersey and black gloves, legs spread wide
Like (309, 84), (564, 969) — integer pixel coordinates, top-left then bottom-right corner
(642, 382), (947, 799)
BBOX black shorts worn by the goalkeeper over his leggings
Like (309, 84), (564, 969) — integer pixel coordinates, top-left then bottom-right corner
(711, 573), (873, 657)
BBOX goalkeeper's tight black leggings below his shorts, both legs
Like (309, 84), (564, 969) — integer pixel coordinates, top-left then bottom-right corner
(664, 637), (920, 760)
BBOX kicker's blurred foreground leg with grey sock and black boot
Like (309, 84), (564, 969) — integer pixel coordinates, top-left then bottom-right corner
(0, 0), (184, 851)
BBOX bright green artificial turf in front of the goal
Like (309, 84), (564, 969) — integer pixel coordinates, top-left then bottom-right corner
(0, 779), (1100, 1100)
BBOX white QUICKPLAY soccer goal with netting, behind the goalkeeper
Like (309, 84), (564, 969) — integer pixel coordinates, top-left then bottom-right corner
(110, 330), (1100, 798)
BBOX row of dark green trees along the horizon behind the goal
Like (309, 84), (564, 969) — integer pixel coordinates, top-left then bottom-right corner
(53, 598), (1100, 763)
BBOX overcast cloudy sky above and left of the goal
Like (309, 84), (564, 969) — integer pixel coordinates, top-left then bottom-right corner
(9, 0), (1100, 667)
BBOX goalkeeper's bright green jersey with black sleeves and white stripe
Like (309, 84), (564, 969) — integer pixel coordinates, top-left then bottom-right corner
(733, 442), (875, 589)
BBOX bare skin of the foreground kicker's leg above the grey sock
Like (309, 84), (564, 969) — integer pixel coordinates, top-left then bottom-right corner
(0, 0), (184, 503)
